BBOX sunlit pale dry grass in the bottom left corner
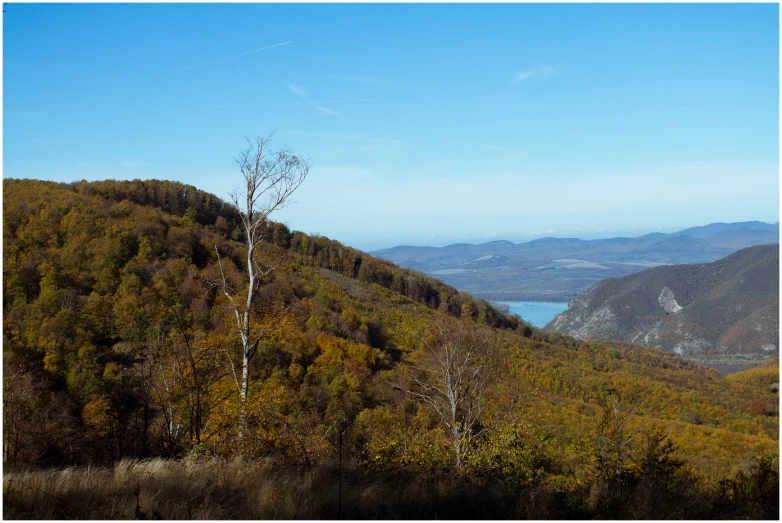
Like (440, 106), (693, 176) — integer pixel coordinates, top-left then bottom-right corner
(3, 458), (324, 519)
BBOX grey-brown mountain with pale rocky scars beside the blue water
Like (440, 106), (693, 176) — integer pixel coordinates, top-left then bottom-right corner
(546, 245), (779, 358)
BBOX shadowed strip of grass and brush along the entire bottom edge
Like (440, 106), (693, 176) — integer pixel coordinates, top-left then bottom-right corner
(3, 457), (779, 520)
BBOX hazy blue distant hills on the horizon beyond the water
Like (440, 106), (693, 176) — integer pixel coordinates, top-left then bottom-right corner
(371, 221), (779, 301)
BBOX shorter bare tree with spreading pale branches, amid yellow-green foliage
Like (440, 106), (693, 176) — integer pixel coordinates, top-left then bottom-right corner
(395, 317), (498, 468)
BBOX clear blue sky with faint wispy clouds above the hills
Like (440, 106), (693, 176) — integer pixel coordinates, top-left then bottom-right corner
(3, 3), (779, 251)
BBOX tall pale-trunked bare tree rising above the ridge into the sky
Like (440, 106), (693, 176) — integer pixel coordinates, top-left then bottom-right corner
(215, 136), (310, 439)
